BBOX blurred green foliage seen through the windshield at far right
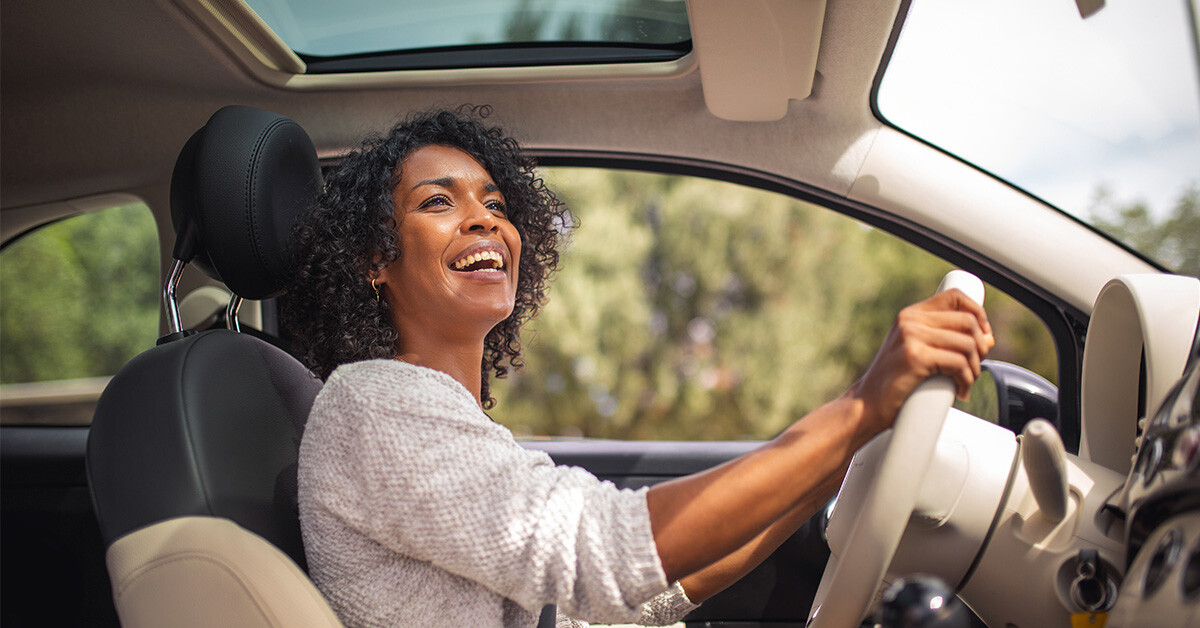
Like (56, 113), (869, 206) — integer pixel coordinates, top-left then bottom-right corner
(1091, 184), (1200, 277)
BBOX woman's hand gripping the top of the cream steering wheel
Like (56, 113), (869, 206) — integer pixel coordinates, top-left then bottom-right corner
(850, 289), (996, 442)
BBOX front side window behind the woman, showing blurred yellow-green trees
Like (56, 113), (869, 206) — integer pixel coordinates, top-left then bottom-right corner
(492, 168), (1056, 441)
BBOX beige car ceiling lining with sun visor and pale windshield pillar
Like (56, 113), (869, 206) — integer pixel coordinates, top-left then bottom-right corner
(0, 0), (1152, 310)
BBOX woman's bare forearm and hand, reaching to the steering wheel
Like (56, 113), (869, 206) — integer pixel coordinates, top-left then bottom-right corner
(647, 291), (995, 585)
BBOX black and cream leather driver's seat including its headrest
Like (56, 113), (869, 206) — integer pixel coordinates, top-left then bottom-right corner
(86, 106), (341, 627)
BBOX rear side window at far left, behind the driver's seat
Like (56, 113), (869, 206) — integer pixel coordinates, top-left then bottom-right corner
(0, 204), (158, 425)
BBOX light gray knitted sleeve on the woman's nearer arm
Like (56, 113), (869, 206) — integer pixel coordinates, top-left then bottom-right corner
(304, 360), (686, 623)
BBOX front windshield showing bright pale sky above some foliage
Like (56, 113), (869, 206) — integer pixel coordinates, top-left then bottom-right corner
(877, 0), (1200, 275)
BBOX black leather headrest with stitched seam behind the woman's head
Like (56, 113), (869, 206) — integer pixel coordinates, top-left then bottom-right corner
(170, 104), (320, 299)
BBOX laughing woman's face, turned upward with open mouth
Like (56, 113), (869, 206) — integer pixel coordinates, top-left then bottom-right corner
(379, 146), (521, 343)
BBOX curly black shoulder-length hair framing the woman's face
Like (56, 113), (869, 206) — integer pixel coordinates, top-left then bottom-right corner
(281, 106), (572, 408)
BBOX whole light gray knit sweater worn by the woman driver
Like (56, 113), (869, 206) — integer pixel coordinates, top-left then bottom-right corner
(299, 360), (695, 627)
